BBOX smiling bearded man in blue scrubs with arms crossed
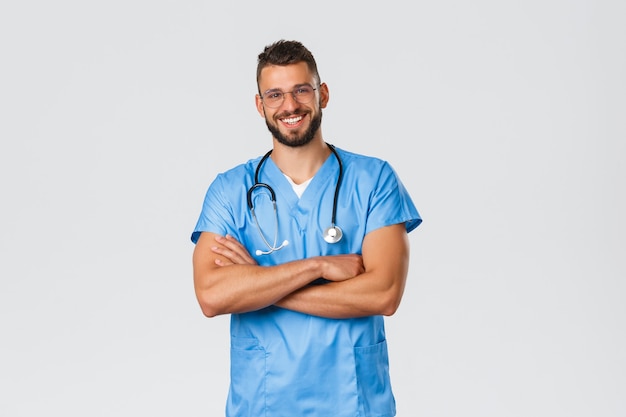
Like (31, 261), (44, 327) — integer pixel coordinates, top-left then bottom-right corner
(191, 40), (422, 417)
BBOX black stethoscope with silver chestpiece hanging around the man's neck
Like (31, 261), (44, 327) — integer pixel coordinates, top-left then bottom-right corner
(247, 143), (343, 256)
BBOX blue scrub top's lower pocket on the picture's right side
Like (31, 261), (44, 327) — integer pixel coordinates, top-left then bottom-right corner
(354, 340), (396, 417)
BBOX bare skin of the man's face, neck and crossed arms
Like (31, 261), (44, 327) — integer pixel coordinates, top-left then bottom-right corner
(193, 63), (409, 319)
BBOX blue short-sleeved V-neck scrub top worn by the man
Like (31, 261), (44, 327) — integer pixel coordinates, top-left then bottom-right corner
(191, 148), (422, 417)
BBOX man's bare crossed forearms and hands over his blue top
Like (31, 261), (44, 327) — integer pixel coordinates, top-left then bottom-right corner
(193, 224), (409, 318)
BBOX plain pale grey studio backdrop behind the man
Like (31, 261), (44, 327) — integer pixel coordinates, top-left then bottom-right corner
(0, 0), (626, 417)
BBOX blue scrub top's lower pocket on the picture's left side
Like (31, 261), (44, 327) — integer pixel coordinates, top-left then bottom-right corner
(227, 337), (267, 417)
